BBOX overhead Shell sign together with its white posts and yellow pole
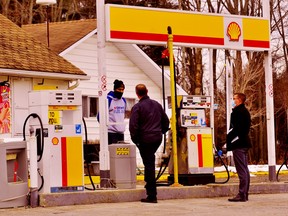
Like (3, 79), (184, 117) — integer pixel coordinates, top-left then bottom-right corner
(97, 0), (276, 183)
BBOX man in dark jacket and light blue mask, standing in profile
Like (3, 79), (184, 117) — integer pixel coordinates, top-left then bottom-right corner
(227, 93), (251, 202)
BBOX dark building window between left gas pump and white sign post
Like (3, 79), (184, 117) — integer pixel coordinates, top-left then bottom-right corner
(82, 96), (99, 118)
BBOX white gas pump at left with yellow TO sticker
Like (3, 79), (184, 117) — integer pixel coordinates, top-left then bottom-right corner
(29, 90), (84, 193)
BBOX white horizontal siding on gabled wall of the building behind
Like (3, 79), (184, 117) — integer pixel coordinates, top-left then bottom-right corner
(63, 35), (166, 165)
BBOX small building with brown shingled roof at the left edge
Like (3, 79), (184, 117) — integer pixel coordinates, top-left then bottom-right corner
(0, 14), (89, 138)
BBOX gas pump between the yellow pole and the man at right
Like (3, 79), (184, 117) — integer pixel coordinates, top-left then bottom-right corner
(168, 95), (215, 185)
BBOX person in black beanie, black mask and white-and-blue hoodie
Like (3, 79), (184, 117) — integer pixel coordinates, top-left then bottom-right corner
(97, 79), (126, 144)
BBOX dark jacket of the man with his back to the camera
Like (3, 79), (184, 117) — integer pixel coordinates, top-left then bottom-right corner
(129, 96), (169, 145)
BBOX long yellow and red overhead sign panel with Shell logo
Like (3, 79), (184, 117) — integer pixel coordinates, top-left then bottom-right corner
(105, 4), (270, 51)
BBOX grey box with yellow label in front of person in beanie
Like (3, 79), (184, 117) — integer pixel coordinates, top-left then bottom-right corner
(109, 144), (136, 189)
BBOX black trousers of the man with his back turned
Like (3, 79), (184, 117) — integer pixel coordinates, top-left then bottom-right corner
(138, 140), (161, 199)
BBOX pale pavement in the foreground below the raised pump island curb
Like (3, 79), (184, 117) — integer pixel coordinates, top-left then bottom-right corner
(0, 193), (288, 216)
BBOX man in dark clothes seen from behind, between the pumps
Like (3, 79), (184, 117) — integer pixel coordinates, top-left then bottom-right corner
(129, 84), (169, 203)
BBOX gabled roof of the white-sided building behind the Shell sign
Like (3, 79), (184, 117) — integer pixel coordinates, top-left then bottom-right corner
(22, 19), (187, 95)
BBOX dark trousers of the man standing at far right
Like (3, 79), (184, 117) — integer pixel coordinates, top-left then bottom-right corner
(232, 148), (250, 197)
